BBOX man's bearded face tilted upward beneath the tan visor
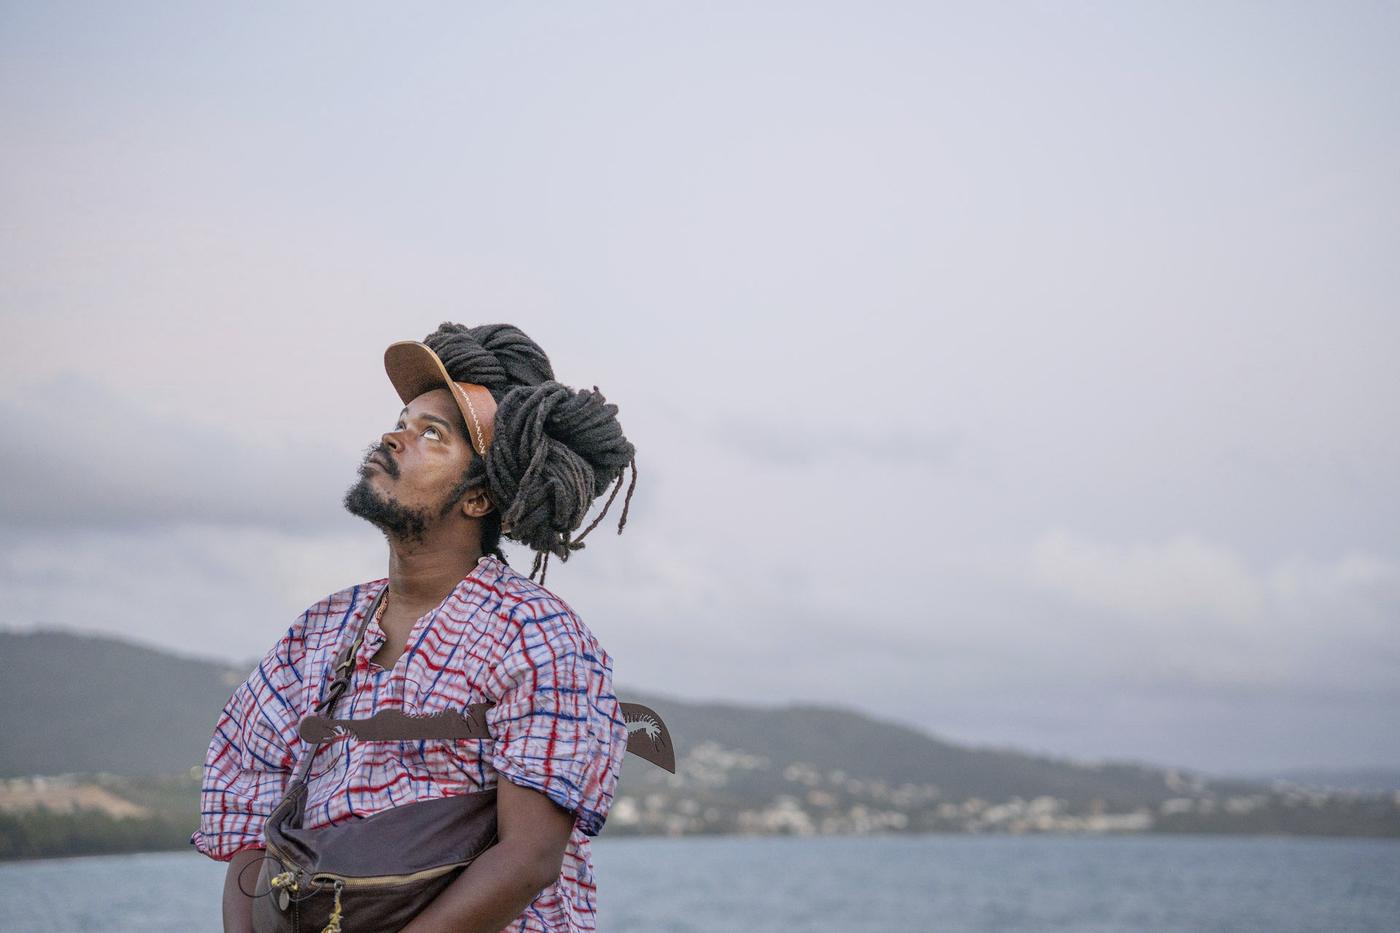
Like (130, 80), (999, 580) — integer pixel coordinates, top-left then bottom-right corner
(344, 387), (472, 542)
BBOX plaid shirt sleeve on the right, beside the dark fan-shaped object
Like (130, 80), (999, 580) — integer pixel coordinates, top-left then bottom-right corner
(486, 597), (627, 836)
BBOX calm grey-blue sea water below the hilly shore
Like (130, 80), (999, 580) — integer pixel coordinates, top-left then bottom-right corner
(0, 835), (1400, 933)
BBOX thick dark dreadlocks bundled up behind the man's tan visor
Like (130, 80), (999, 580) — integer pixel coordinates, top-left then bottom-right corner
(423, 322), (637, 583)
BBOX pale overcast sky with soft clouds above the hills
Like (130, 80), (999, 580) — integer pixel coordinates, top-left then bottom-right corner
(0, 3), (1400, 773)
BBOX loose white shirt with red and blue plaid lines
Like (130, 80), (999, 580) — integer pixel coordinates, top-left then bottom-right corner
(190, 556), (627, 933)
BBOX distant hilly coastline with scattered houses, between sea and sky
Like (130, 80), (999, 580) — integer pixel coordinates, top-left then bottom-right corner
(0, 630), (1400, 859)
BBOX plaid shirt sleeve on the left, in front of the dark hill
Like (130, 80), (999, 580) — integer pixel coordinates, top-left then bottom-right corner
(189, 609), (311, 862)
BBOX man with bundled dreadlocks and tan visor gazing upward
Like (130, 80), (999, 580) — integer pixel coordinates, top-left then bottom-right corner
(190, 324), (636, 933)
